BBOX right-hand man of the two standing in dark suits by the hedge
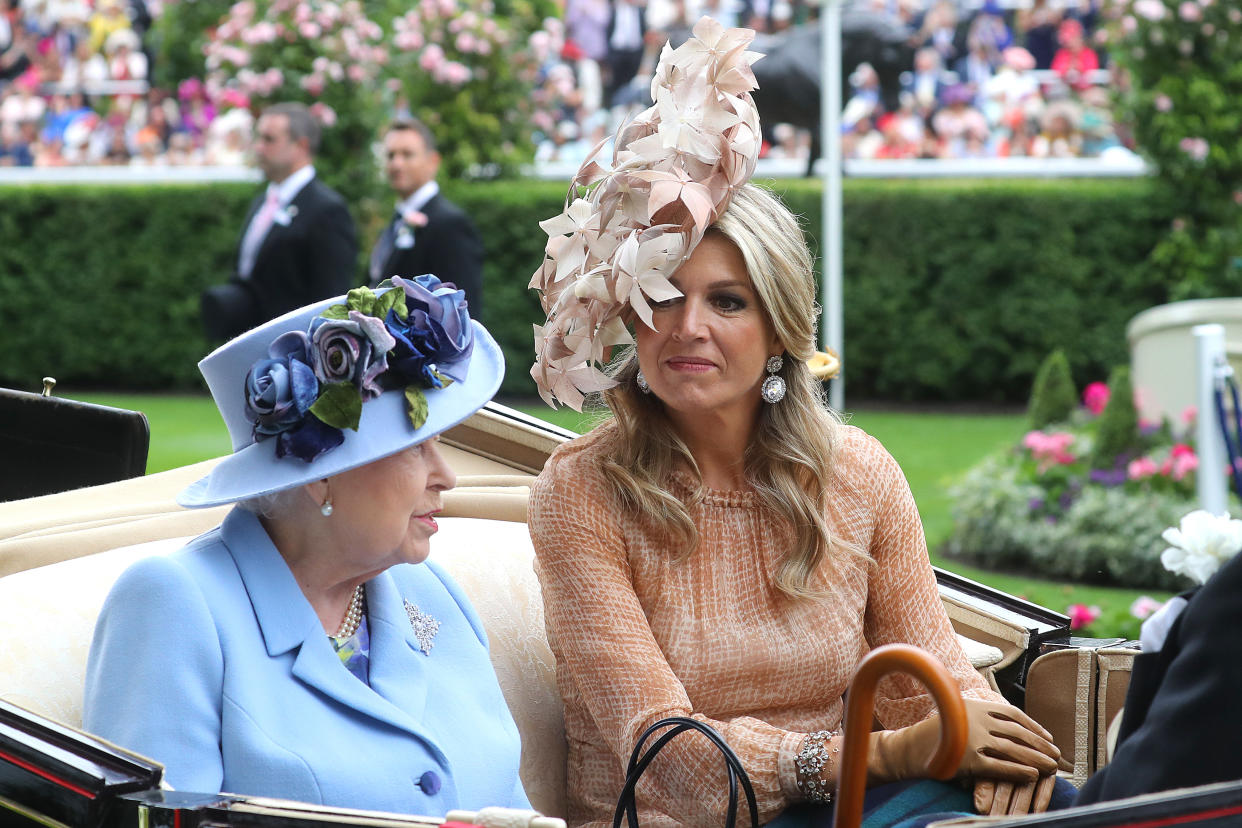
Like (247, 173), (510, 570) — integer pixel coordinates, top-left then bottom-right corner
(368, 119), (483, 319)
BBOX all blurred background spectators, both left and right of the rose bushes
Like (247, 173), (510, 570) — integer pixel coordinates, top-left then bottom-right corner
(0, 0), (1122, 166)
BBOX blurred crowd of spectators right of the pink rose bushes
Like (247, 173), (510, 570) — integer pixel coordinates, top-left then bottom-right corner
(537, 0), (1125, 163)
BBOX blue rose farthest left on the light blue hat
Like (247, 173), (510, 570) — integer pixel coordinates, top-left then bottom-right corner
(246, 330), (319, 439)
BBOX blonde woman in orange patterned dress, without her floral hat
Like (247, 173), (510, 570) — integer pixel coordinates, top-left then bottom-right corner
(530, 185), (1059, 826)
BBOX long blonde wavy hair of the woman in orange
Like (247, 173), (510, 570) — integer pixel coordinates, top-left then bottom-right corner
(602, 184), (851, 597)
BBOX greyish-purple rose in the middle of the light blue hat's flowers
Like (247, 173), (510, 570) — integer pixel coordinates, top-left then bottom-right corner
(311, 310), (395, 401)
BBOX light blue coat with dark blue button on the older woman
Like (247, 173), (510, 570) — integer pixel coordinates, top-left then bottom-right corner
(83, 509), (529, 816)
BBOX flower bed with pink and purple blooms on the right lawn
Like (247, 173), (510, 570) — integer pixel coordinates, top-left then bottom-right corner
(943, 381), (1199, 591)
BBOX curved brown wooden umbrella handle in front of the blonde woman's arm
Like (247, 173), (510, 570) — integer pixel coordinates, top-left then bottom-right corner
(832, 644), (966, 828)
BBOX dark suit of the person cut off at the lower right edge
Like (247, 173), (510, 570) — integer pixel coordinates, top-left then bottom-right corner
(1074, 546), (1242, 804)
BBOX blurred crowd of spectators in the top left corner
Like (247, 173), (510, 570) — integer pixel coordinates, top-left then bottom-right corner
(0, 0), (251, 166)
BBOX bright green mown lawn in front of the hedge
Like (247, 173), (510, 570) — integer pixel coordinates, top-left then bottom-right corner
(72, 394), (1167, 636)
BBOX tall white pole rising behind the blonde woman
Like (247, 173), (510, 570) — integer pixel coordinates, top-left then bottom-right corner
(820, 0), (846, 411)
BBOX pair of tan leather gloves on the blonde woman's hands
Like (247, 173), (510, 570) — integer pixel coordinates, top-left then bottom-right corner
(867, 699), (1061, 785)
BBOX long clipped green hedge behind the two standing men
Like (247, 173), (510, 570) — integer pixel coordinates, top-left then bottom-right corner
(0, 180), (1182, 402)
